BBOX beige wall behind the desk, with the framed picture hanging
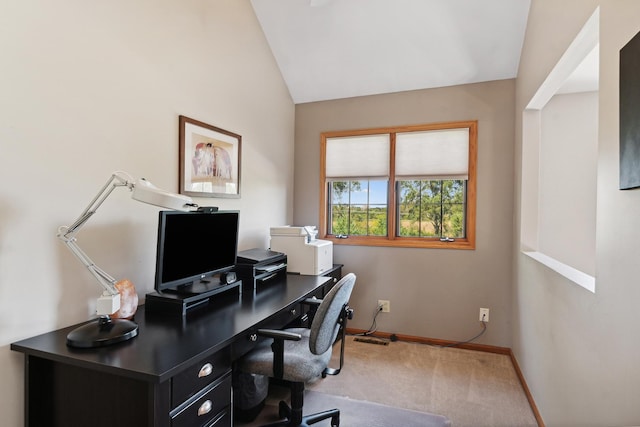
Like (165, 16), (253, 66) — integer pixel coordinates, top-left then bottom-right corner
(0, 0), (294, 427)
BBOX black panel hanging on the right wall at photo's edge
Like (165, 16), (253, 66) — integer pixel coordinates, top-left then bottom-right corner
(620, 29), (640, 190)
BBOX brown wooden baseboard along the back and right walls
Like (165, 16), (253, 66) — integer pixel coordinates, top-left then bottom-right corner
(347, 328), (545, 427)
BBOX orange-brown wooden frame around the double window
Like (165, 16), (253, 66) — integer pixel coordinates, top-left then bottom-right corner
(318, 120), (478, 249)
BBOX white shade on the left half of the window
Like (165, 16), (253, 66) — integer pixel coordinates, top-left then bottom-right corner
(325, 134), (390, 181)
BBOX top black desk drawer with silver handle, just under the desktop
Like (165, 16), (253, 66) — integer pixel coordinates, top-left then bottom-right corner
(171, 349), (231, 408)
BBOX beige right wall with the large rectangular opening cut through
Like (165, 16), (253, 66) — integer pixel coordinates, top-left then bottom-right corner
(512, 0), (640, 427)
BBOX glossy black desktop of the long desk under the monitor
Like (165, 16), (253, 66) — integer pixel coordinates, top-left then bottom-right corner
(11, 274), (330, 383)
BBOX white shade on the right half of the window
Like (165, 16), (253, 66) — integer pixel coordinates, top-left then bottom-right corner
(396, 128), (469, 179)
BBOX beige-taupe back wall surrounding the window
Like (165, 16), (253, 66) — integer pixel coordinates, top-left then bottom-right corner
(294, 80), (515, 347)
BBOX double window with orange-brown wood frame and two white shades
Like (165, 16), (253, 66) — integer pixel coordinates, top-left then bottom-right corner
(320, 121), (477, 249)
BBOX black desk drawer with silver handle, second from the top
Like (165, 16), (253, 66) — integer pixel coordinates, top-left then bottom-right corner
(171, 372), (231, 427)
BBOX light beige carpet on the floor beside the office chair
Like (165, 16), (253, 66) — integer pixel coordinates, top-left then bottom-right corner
(307, 337), (538, 427)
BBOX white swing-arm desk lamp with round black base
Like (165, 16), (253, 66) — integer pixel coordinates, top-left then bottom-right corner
(58, 172), (197, 348)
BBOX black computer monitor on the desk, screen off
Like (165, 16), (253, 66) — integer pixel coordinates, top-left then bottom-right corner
(155, 211), (239, 291)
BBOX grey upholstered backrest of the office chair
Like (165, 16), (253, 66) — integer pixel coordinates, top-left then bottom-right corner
(309, 273), (356, 354)
